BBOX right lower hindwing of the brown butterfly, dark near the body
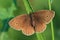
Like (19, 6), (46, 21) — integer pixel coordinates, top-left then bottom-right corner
(32, 15), (46, 33)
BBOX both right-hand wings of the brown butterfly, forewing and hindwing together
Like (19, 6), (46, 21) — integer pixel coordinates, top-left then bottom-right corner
(33, 10), (55, 32)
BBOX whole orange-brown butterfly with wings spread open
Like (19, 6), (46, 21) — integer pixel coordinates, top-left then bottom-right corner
(9, 10), (55, 36)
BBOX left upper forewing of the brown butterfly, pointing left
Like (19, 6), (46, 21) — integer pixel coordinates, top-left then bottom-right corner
(9, 14), (27, 30)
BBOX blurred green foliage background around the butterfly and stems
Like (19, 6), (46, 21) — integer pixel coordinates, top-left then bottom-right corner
(0, 0), (60, 40)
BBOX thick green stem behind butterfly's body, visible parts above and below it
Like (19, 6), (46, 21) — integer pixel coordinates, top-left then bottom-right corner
(23, 0), (43, 40)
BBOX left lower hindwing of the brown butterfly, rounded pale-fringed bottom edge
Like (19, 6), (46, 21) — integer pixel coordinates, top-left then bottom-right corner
(22, 15), (34, 36)
